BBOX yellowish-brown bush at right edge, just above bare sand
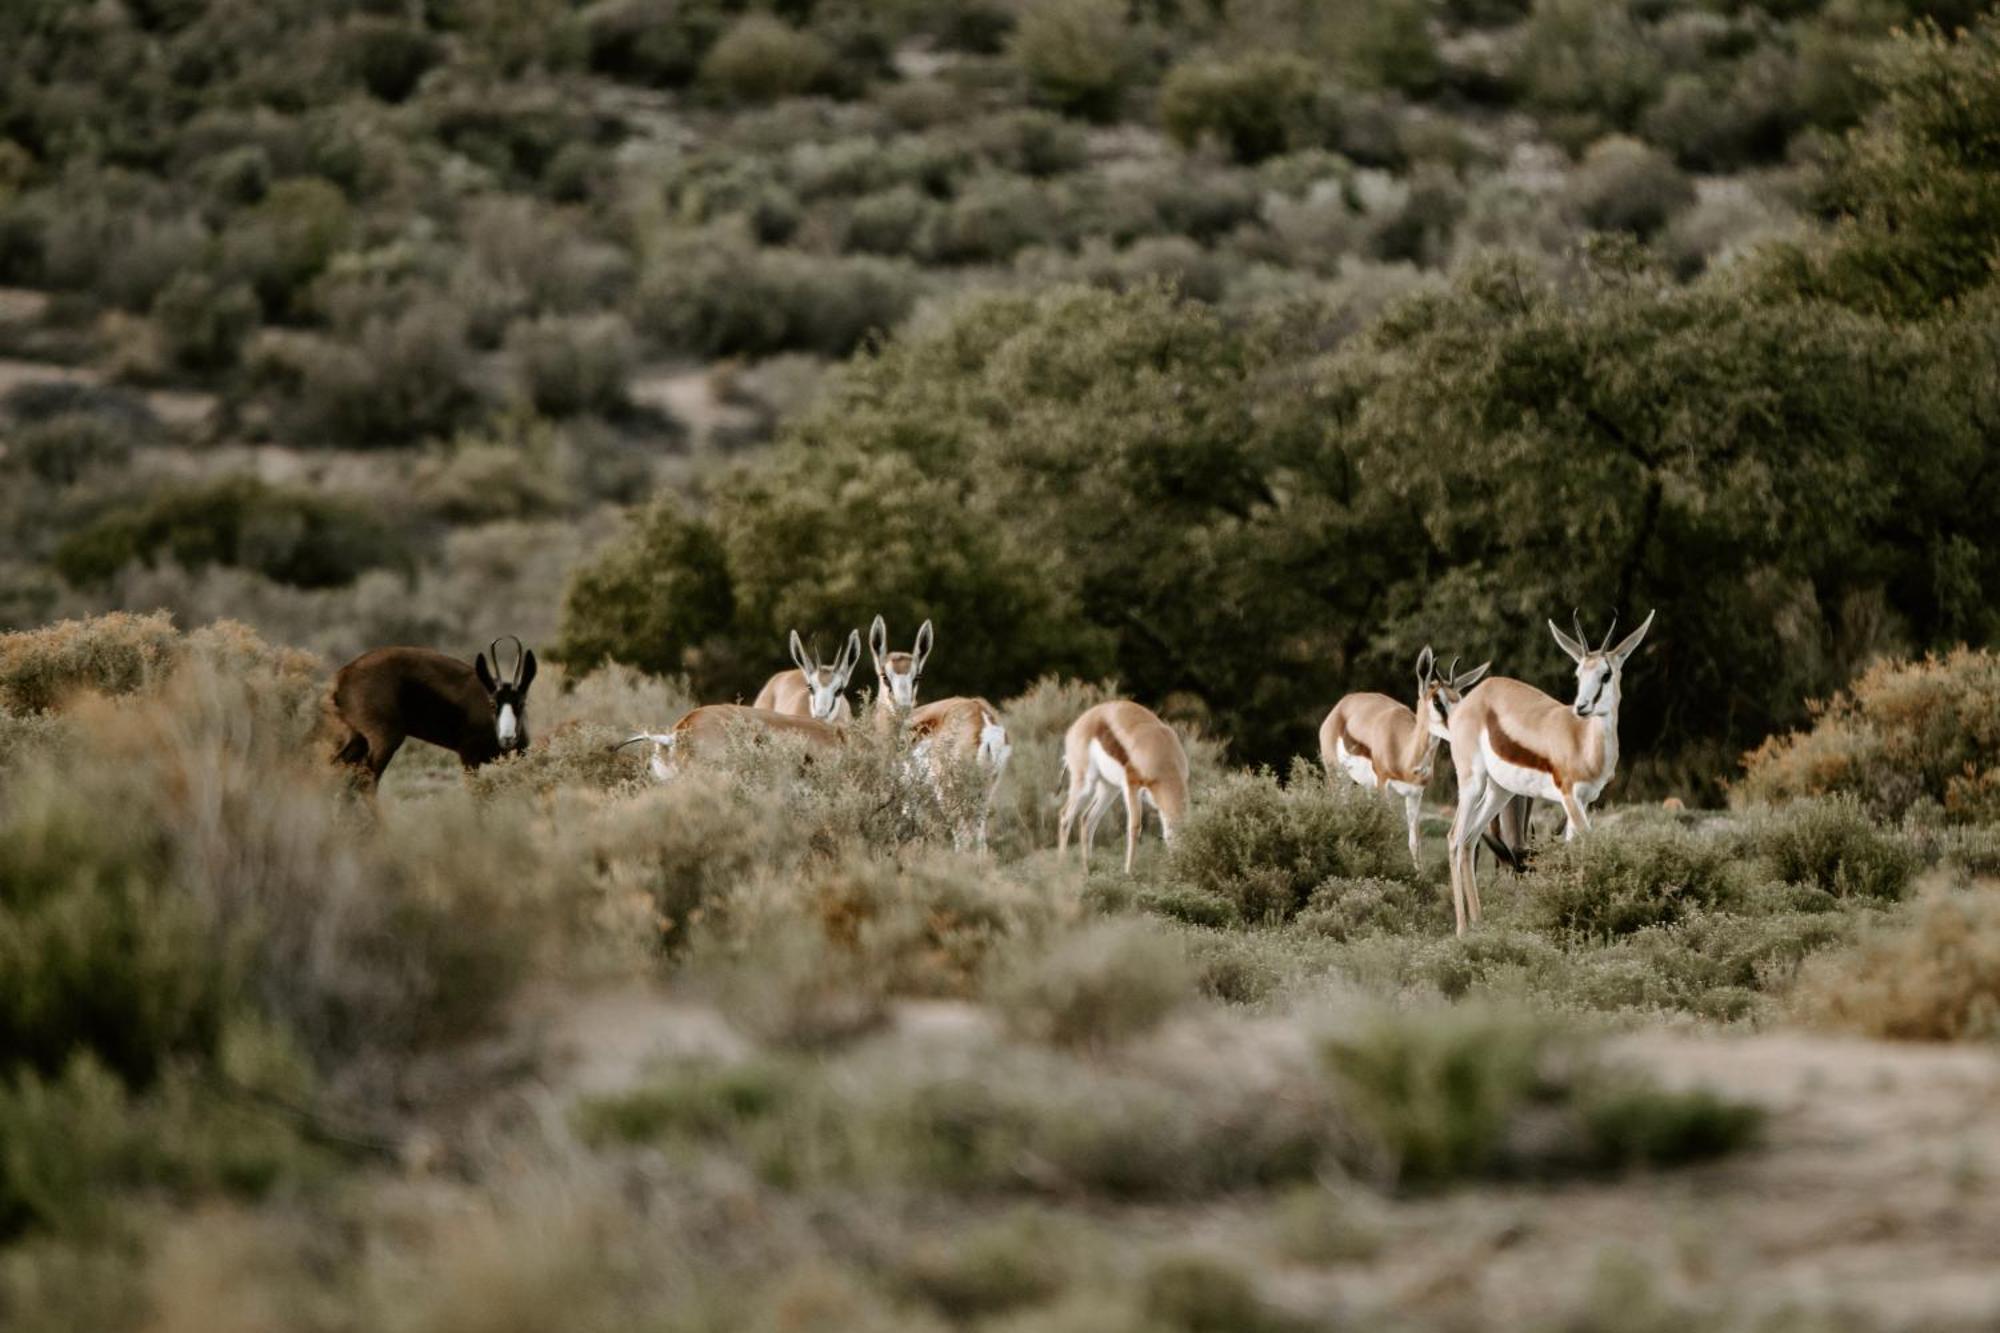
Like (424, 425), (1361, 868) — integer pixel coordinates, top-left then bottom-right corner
(1792, 891), (2000, 1041)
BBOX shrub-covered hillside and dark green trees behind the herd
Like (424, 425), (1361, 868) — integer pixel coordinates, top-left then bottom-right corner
(0, 0), (2000, 797)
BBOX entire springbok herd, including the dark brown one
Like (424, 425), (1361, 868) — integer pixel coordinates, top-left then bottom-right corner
(328, 614), (1652, 935)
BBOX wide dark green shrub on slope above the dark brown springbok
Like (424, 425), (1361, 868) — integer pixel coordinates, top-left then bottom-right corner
(52, 476), (406, 588)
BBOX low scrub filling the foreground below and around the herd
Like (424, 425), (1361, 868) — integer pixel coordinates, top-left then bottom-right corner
(0, 616), (2000, 1331)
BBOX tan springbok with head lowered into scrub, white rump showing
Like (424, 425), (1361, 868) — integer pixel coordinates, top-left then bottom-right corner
(1056, 699), (1188, 875)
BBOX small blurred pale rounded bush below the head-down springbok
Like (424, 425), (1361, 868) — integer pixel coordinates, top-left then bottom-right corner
(994, 921), (1194, 1047)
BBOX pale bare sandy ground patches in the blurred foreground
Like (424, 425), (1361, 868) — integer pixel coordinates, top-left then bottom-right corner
(532, 989), (2000, 1329)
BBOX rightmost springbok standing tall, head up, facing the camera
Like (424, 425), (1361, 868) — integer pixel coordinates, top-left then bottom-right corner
(1448, 612), (1658, 935)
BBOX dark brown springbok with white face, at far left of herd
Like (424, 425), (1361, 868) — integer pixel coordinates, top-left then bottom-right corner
(326, 636), (534, 789)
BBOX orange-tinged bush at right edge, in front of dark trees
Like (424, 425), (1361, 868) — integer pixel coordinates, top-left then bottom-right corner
(1732, 648), (2000, 821)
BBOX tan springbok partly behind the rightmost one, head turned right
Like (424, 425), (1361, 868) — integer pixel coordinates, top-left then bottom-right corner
(1320, 644), (1492, 867)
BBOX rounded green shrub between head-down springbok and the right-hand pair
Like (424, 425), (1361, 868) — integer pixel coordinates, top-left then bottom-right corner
(1170, 761), (1410, 921)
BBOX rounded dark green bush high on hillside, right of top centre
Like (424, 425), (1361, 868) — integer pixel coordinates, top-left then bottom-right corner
(1160, 52), (1336, 162)
